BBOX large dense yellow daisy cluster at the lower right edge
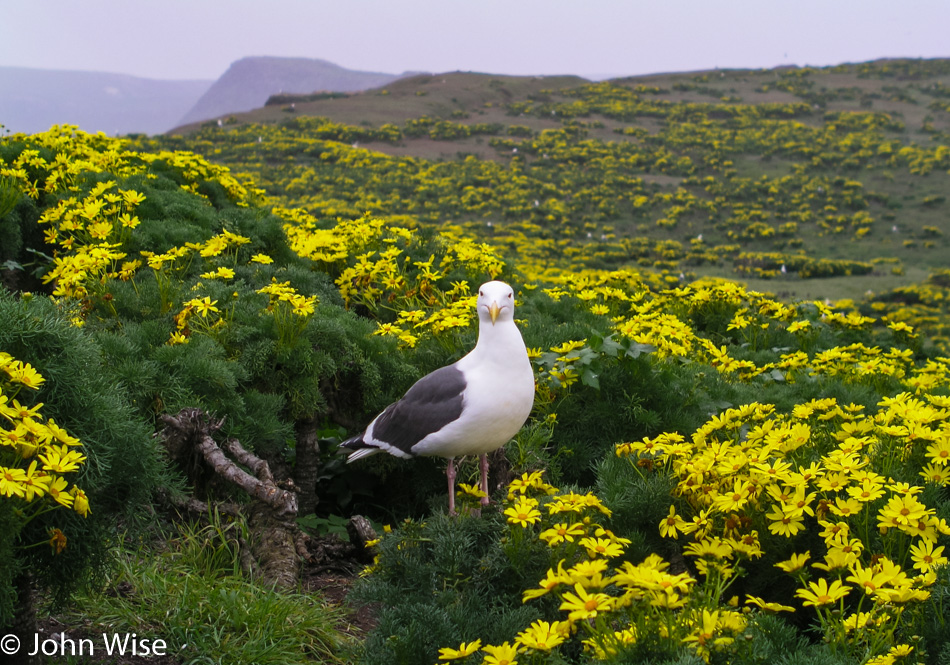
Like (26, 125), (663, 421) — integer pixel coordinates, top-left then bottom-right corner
(616, 393), (950, 655)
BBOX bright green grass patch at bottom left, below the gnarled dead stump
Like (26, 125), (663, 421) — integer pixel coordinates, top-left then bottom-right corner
(67, 525), (354, 665)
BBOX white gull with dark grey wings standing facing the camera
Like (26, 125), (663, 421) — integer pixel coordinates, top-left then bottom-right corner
(340, 281), (534, 515)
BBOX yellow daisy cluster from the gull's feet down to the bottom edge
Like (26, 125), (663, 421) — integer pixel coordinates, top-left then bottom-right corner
(441, 471), (760, 663)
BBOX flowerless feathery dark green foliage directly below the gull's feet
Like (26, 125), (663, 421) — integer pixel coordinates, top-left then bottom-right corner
(351, 514), (546, 665)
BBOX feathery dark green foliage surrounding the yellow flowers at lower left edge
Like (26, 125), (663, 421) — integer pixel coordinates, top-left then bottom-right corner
(0, 291), (168, 616)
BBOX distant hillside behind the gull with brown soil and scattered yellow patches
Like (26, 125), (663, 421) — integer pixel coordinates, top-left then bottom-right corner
(157, 60), (950, 298)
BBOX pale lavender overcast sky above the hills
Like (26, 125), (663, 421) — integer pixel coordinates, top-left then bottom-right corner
(0, 0), (950, 79)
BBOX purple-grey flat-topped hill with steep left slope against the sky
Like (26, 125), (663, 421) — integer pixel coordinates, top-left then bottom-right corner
(178, 57), (412, 125)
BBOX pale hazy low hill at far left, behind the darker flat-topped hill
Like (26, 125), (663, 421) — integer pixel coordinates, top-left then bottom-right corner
(0, 67), (212, 135)
